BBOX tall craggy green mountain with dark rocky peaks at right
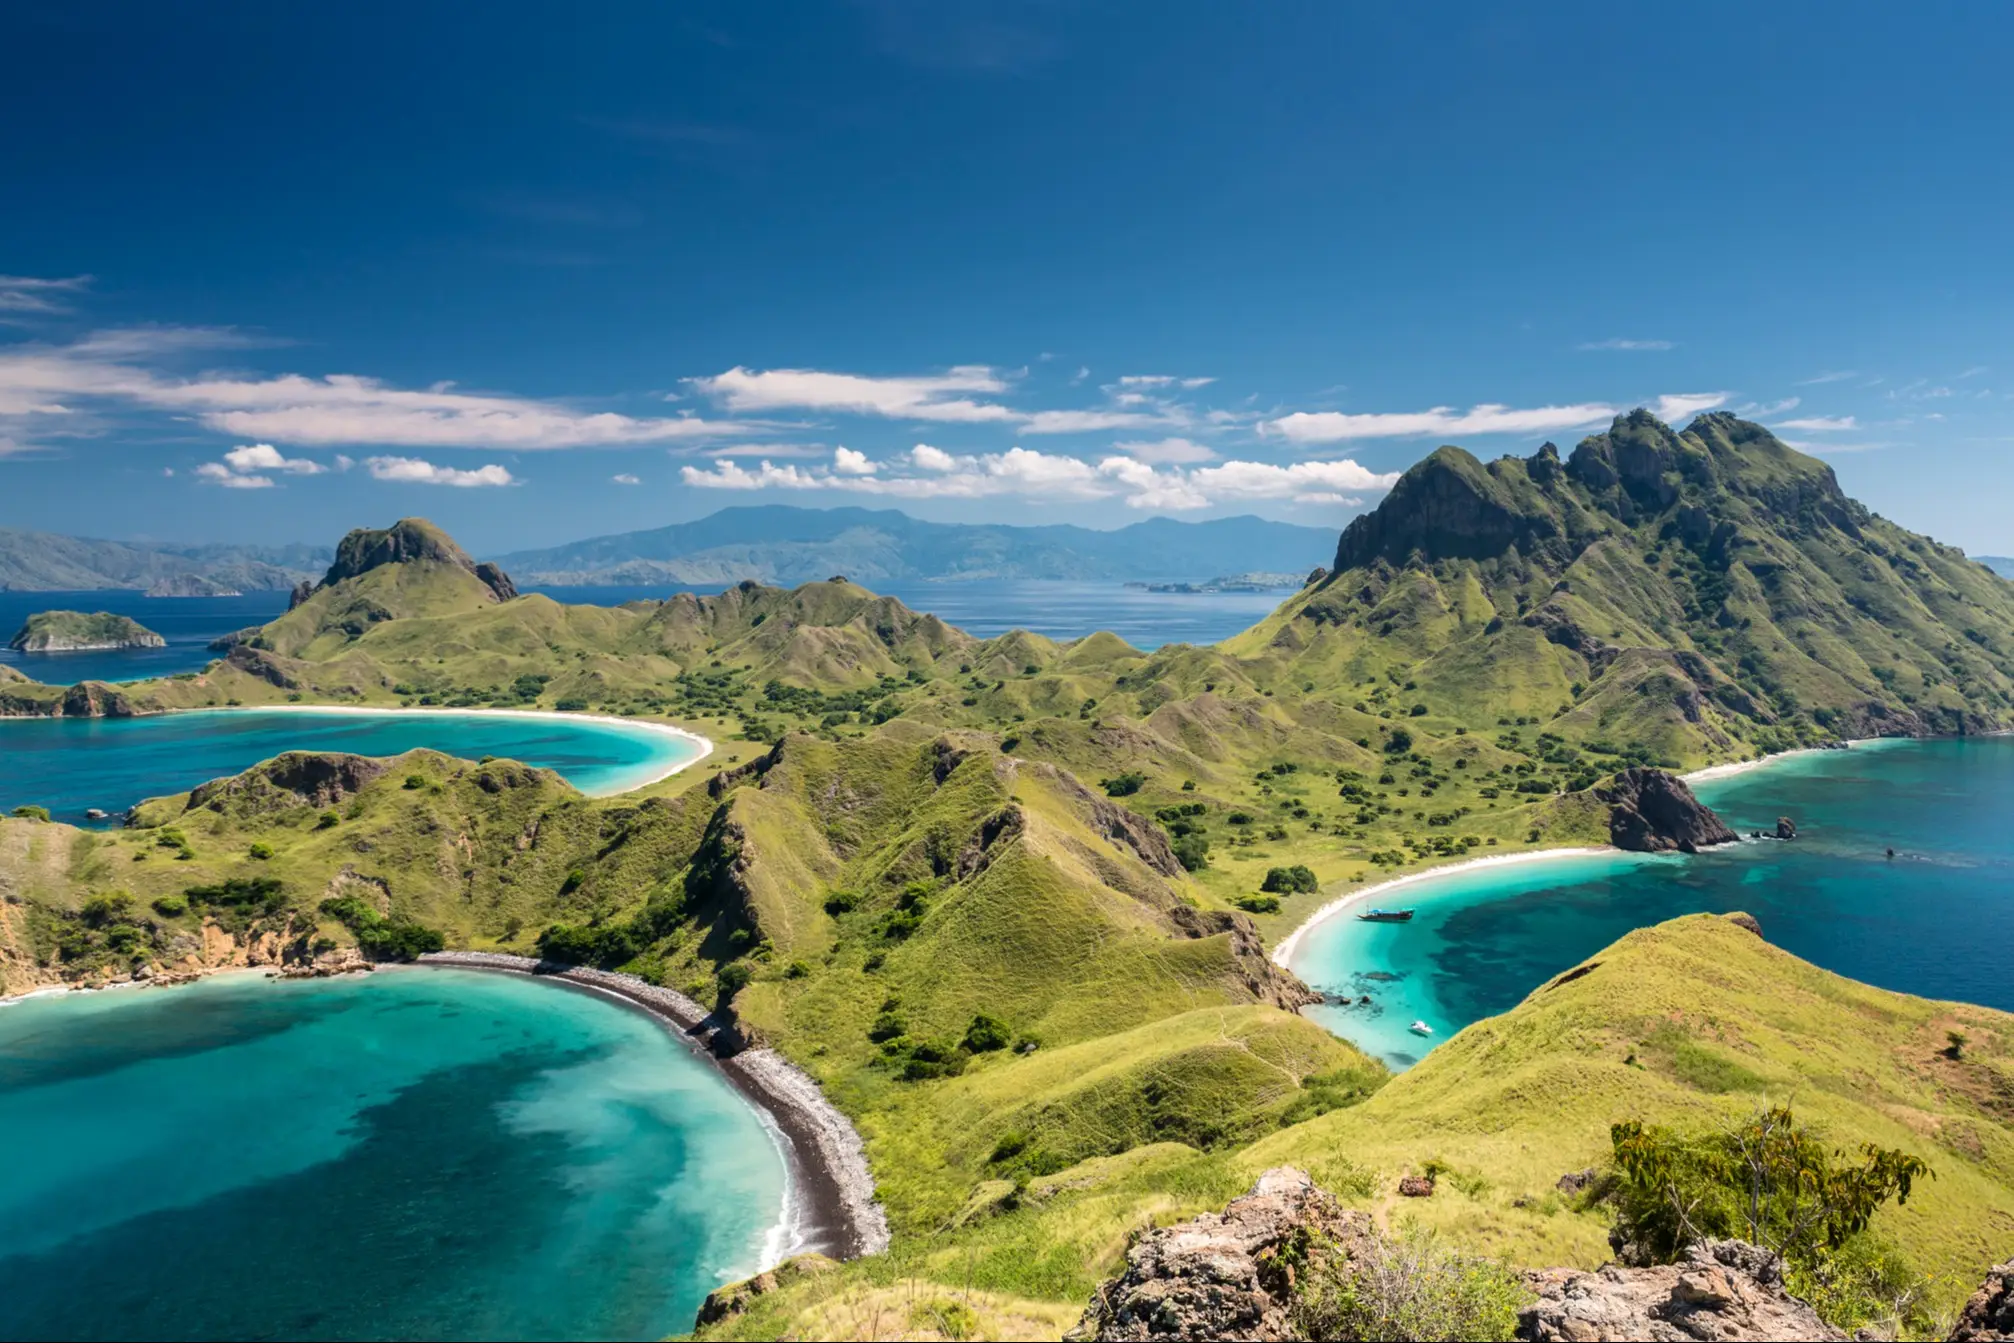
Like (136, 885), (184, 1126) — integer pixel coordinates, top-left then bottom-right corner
(1229, 411), (2014, 757)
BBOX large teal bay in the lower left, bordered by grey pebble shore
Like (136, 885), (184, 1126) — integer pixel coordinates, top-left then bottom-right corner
(0, 971), (783, 1339)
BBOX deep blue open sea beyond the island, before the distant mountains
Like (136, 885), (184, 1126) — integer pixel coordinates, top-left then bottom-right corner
(0, 580), (1289, 685)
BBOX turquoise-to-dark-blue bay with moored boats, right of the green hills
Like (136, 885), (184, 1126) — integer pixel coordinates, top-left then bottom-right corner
(1293, 737), (2014, 1067)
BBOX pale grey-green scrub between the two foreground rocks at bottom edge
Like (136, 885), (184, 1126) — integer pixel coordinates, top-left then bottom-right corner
(1293, 1230), (1531, 1341)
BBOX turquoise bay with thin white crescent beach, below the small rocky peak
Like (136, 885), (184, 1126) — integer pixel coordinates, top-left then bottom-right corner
(0, 709), (699, 824)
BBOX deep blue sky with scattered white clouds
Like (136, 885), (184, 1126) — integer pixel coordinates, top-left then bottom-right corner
(0, 2), (2014, 554)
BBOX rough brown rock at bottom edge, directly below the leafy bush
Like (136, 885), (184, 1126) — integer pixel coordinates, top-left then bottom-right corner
(1517, 1240), (1847, 1343)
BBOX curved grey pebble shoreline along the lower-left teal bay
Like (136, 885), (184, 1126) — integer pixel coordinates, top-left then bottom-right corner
(417, 950), (888, 1273)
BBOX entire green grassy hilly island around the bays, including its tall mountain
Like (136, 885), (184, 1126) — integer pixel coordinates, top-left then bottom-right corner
(0, 411), (2014, 1339)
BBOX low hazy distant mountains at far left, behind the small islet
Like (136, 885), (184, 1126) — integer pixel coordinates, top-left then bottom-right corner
(0, 528), (334, 596)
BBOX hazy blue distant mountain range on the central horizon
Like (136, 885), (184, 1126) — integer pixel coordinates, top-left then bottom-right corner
(485, 505), (1335, 586)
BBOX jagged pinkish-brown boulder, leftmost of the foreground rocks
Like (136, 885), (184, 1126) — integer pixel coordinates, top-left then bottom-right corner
(1065, 1166), (1372, 1339)
